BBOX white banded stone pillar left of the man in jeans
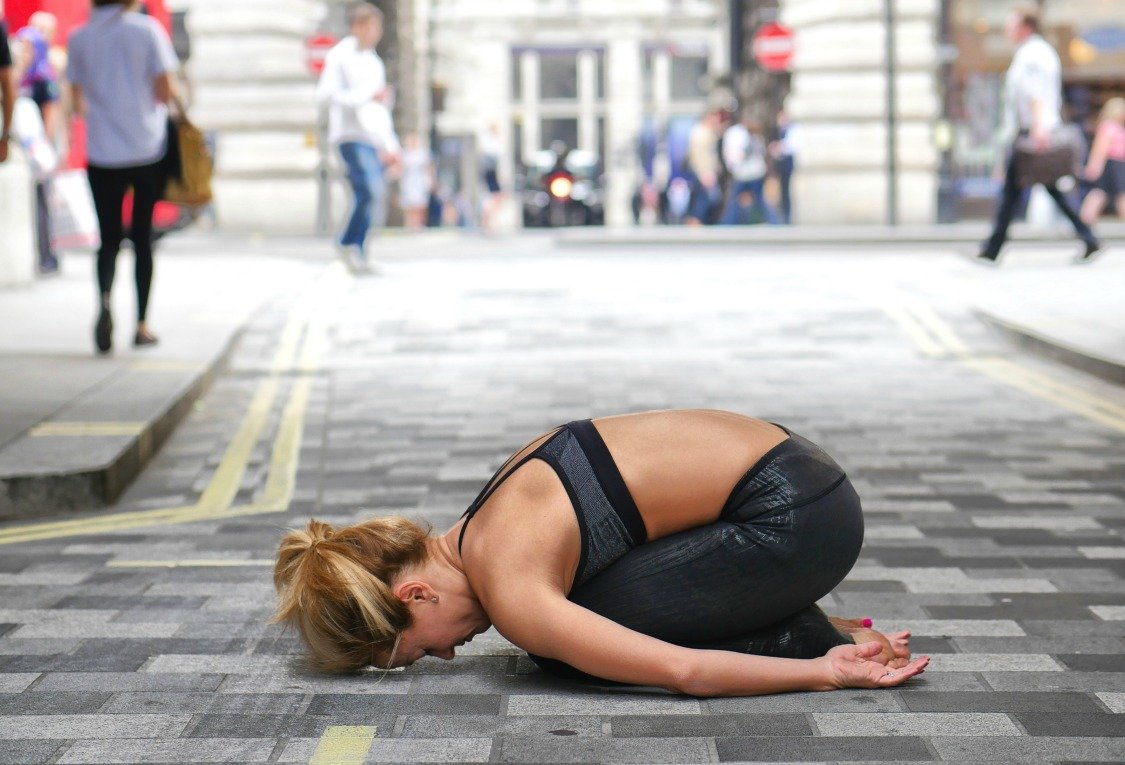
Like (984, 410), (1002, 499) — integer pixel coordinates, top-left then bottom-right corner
(177, 0), (324, 234)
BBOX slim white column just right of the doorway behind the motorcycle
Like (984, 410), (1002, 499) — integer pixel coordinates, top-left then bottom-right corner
(605, 35), (645, 226)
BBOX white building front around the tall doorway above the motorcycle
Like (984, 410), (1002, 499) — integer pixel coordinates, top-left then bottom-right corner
(419, 0), (729, 225)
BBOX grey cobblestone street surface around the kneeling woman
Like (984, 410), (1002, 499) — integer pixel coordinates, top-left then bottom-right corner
(0, 239), (1125, 763)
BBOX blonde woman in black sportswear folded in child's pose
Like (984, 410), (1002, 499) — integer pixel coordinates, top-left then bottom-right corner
(275, 410), (928, 696)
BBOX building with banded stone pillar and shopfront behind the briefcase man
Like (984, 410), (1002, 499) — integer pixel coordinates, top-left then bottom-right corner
(730, 0), (1125, 224)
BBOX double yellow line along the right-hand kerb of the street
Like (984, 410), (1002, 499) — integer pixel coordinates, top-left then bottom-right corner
(882, 300), (1125, 432)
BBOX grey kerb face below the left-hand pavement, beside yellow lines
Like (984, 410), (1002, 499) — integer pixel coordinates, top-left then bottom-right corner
(0, 326), (245, 521)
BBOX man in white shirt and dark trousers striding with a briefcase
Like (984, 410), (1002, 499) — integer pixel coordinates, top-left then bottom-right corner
(974, 6), (1101, 263)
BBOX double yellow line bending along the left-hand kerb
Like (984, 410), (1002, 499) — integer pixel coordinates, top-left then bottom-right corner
(0, 263), (349, 545)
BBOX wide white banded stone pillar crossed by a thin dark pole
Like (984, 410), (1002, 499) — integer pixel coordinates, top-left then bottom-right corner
(781, 0), (941, 224)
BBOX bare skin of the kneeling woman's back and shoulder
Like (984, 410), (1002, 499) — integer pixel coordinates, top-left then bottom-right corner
(455, 410), (786, 590)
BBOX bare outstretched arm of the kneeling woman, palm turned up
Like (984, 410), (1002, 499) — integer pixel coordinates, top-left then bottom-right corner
(486, 585), (929, 696)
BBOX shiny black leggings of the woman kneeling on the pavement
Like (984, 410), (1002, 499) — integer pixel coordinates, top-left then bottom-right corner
(531, 452), (863, 678)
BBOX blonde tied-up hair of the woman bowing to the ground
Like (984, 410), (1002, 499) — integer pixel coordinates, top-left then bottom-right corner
(270, 516), (430, 672)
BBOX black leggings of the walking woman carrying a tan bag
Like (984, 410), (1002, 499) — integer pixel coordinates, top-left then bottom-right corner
(87, 160), (168, 322)
